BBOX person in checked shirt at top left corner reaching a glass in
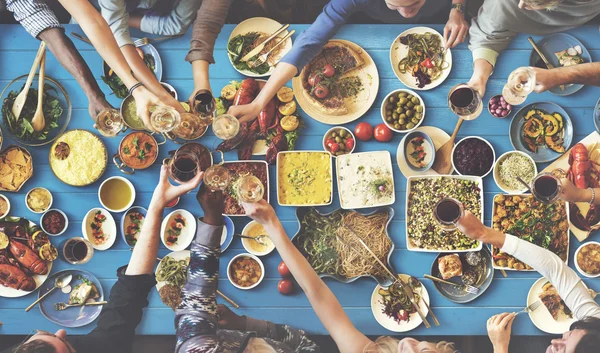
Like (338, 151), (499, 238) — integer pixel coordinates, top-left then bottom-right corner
(5, 0), (112, 121)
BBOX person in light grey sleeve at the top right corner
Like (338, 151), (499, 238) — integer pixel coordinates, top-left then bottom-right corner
(469, 0), (600, 96)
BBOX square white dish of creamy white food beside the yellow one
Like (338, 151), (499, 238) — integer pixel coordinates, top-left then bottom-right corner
(336, 151), (396, 210)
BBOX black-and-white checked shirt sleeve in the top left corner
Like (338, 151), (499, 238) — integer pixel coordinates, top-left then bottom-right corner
(6, 0), (62, 38)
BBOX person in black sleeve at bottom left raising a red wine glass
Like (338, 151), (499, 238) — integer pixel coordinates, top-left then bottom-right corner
(7, 164), (202, 353)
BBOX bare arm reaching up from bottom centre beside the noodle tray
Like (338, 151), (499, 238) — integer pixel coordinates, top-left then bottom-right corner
(242, 200), (371, 353)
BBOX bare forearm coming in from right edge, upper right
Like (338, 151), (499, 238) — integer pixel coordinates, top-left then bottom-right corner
(532, 63), (600, 93)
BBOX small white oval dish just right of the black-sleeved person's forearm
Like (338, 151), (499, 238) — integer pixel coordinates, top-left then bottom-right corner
(160, 209), (196, 251)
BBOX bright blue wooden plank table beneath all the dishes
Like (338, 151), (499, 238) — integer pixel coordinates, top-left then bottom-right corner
(0, 25), (600, 335)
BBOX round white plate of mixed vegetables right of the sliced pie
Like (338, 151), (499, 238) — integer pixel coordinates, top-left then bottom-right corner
(390, 27), (452, 90)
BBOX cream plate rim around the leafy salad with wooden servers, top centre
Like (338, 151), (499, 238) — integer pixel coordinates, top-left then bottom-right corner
(225, 17), (292, 77)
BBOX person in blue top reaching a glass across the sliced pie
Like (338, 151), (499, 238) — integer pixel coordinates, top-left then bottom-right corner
(229, 0), (469, 122)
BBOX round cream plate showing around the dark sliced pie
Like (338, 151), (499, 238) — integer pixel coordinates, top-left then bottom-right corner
(292, 39), (379, 125)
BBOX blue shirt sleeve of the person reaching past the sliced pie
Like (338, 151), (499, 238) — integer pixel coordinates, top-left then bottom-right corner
(281, 0), (372, 72)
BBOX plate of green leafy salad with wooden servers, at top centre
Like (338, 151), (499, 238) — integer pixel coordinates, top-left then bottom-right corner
(227, 17), (292, 77)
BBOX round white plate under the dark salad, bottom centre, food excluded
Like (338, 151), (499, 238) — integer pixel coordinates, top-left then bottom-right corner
(371, 274), (429, 332)
